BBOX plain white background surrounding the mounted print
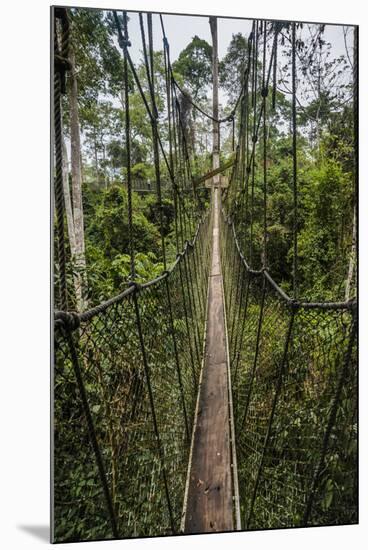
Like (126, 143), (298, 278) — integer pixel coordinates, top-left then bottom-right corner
(0, 0), (368, 550)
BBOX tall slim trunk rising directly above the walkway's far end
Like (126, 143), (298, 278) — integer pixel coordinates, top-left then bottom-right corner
(210, 17), (220, 185)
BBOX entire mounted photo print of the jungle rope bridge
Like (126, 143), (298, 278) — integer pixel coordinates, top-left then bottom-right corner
(51, 7), (358, 542)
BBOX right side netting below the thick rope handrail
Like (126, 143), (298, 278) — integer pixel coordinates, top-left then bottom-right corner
(222, 213), (357, 529)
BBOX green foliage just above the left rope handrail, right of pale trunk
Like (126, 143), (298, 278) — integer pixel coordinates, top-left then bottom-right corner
(84, 188), (168, 303)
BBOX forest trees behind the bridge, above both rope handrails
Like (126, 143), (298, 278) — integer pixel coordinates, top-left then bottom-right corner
(55, 9), (356, 310)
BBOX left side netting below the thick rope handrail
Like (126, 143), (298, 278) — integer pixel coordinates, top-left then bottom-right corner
(54, 212), (210, 540)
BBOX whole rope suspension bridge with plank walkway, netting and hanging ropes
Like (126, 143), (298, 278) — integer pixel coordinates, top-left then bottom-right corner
(53, 9), (357, 541)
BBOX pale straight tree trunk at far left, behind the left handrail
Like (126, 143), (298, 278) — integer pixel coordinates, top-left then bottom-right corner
(69, 50), (87, 311)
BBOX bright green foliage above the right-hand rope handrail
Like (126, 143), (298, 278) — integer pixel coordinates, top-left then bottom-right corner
(236, 128), (354, 301)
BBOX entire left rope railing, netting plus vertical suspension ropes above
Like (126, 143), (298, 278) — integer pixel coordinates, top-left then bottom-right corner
(53, 8), (212, 542)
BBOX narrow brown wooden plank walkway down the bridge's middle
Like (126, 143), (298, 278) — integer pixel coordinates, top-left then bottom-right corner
(184, 189), (234, 533)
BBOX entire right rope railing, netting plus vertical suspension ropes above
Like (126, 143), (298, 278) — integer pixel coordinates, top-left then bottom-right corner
(221, 21), (357, 529)
